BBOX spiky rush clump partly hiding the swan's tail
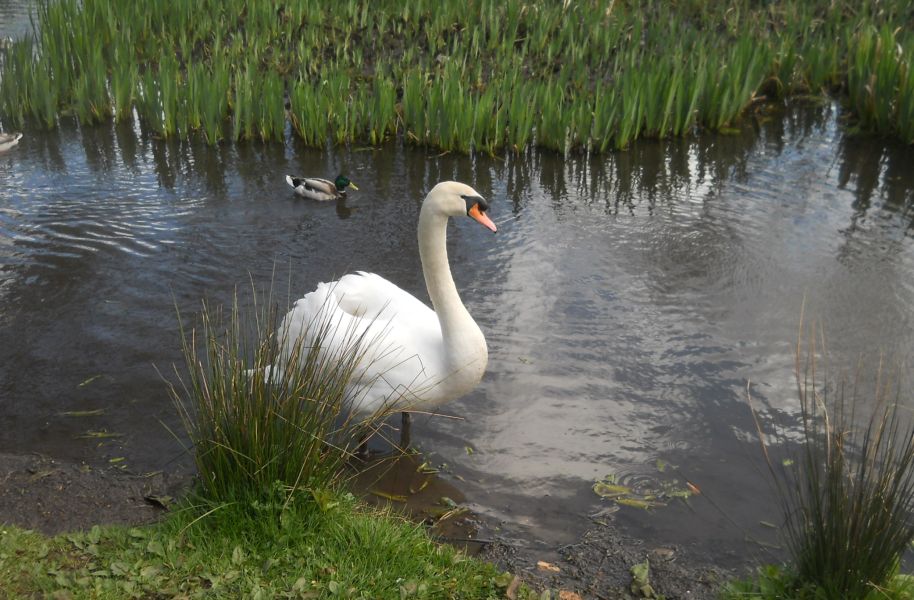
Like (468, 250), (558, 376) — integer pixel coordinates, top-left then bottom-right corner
(170, 288), (383, 502)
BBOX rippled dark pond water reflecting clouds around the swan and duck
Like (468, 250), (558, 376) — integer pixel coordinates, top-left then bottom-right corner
(0, 8), (914, 565)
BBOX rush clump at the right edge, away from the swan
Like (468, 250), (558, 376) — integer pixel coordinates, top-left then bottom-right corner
(731, 331), (914, 600)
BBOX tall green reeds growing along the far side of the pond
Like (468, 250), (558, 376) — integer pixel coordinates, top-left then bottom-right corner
(0, 0), (914, 153)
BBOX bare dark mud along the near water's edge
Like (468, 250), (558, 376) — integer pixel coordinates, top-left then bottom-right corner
(0, 454), (738, 599)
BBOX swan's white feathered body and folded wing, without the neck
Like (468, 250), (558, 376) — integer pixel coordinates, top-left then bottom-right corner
(282, 272), (444, 412)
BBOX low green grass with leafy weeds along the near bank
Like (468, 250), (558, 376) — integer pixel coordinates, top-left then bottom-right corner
(0, 493), (538, 600)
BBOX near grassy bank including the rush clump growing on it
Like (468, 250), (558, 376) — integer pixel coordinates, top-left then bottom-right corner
(0, 294), (551, 599)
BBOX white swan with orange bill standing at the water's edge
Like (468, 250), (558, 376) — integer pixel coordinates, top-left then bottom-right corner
(279, 181), (496, 447)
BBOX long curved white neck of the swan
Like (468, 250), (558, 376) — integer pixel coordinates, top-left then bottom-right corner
(419, 201), (487, 368)
